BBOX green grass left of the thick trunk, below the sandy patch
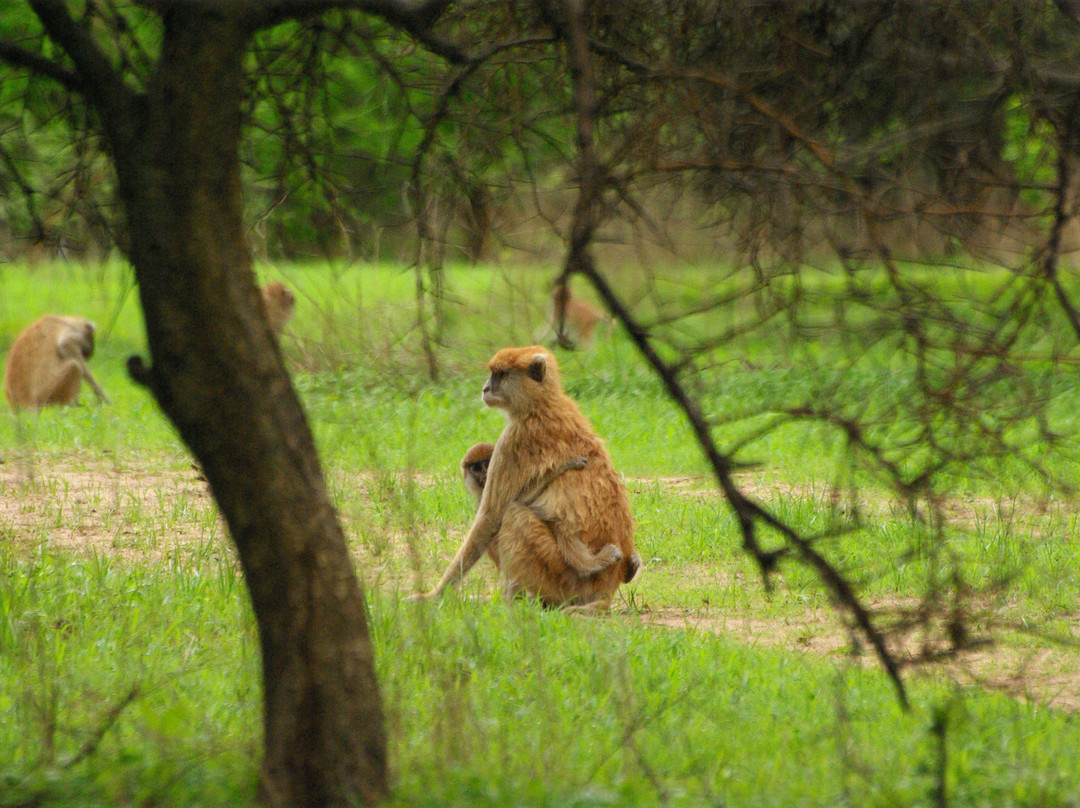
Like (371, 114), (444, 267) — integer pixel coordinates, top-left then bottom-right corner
(0, 543), (259, 806)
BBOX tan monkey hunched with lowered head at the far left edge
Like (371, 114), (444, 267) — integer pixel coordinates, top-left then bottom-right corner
(3, 314), (109, 409)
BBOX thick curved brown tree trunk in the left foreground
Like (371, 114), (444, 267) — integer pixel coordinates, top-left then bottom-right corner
(106, 9), (387, 806)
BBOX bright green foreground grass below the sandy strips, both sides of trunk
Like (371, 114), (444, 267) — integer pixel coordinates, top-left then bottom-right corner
(6, 550), (1080, 806)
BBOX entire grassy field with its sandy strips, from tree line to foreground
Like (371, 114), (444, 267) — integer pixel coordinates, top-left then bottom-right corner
(0, 266), (1080, 806)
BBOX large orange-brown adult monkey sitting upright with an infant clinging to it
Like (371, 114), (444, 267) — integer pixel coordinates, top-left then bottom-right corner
(414, 346), (640, 609)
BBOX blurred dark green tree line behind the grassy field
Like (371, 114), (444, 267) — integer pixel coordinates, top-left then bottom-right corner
(0, 1), (1075, 259)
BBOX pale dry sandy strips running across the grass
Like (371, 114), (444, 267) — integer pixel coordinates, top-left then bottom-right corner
(0, 457), (1080, 710)
